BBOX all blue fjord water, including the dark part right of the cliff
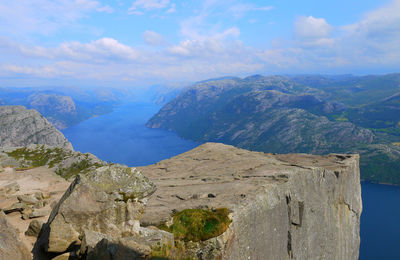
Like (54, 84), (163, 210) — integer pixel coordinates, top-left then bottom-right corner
(63, 103), (400, 260)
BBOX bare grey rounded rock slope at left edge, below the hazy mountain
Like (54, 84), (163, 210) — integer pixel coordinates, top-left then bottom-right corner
(0, 106), (72, 149)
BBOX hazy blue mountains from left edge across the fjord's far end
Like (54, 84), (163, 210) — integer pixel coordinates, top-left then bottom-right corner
(0, 85), (181, 130)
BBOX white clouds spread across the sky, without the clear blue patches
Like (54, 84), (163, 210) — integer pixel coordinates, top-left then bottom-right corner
(0, 0), (400, 84)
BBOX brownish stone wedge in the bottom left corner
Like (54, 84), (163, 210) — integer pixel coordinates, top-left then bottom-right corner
(0, 212), (32, 260)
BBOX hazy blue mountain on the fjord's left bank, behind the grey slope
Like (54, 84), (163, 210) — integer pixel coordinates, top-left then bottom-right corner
(0, 88), (126, 129)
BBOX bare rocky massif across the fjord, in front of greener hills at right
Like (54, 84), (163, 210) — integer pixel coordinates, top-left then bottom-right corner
(147, 80), (374, 154)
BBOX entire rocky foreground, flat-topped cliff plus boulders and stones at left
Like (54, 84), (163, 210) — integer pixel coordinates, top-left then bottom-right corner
(0, 143), (362, 259)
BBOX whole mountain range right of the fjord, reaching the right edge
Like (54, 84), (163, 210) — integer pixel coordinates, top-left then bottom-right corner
(147, 74), (400, 184)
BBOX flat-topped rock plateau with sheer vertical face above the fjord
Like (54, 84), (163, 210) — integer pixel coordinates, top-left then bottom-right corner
(140, 143), (362, 259)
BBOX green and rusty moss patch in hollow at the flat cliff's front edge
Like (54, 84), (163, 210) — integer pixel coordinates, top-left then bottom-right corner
(159, 208), (231, 242)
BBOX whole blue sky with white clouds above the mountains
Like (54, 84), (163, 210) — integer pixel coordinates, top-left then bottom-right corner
(0, 0), (400, 86)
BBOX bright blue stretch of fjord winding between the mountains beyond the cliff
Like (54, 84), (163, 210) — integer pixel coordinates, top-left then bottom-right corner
(62, 103), (199, 166)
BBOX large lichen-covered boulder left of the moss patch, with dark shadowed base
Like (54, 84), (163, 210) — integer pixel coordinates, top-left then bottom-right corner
(36, 165), (155, 253)
